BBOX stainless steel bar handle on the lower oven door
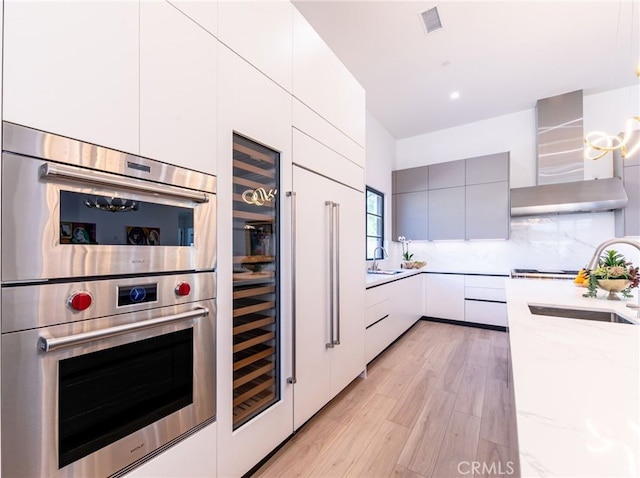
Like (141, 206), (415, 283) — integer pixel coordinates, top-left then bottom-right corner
(38, 307), (209, 352)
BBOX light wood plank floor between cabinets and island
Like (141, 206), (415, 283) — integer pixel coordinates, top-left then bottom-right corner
(254, 321), (520, 478)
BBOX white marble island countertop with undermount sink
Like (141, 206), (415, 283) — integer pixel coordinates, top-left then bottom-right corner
(506, 279), (640, 478)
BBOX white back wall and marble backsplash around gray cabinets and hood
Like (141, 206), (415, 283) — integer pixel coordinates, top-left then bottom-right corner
(390, 86), (640, 272)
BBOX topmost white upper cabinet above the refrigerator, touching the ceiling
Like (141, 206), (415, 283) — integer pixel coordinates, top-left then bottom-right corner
(292, 8), (366, 146)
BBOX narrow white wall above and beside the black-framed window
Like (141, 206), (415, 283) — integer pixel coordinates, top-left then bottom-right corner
(365, 112), (396, 268)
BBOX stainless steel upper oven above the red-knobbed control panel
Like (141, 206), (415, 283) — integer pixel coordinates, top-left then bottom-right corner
(1, 122), (216, 283)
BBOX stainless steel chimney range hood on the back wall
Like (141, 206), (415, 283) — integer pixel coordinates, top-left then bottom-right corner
(511, 90), (628, 217)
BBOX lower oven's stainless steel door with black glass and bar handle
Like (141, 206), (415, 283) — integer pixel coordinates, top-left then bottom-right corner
(0, 300), (216, 478)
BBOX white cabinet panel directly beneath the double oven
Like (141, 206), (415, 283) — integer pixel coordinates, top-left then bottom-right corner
(126, 423), (217, 478)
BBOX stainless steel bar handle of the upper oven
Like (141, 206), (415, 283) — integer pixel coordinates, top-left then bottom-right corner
(40, 163), (209, 203)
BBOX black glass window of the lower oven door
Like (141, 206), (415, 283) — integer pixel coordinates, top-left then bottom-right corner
(58, 328), (193, 468)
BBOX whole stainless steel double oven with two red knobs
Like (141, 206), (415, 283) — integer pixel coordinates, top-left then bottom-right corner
(0, 123), (216, 477)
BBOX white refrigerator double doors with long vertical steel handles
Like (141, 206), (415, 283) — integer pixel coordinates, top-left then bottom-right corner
(293, 164), (365, 428)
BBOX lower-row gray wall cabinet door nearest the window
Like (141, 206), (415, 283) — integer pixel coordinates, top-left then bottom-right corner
(393, 191), (429, 241)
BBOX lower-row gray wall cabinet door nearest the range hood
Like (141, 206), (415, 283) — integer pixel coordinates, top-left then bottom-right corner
(465, 181), (510, 239)
